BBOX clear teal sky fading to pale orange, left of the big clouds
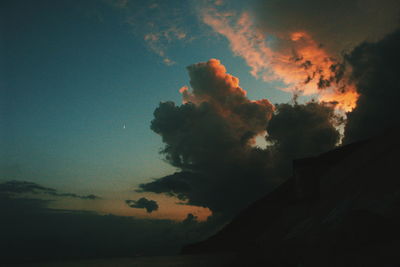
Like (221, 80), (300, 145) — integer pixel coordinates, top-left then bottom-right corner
(0, 0), (290, 220)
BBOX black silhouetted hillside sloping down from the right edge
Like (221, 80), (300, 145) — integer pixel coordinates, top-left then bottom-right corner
(183, 129), (400, 266)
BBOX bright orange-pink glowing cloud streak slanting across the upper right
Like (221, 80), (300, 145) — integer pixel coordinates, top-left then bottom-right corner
(202, 8), (358, 112)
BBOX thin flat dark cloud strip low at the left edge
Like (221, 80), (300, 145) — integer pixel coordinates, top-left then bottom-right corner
(0, 181), (100, 200)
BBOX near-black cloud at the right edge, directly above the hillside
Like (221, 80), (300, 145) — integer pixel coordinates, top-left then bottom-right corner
(344, 30), (400, 143)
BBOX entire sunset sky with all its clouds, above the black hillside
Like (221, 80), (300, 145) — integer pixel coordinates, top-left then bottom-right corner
(0, 0), (400, 262)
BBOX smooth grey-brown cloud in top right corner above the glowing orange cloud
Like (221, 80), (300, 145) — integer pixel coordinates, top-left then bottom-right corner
(254, 0), (400, 54)
